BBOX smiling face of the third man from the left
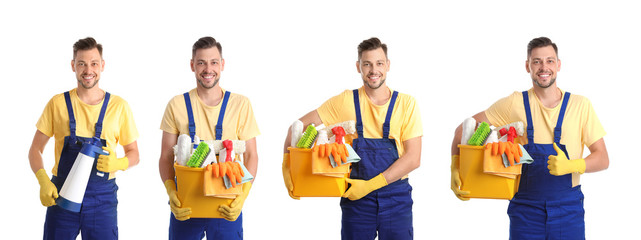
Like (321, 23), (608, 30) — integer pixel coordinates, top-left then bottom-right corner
(356, 48), (390, 89)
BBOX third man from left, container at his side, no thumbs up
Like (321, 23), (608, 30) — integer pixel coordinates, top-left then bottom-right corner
(283, 38), (423, 240)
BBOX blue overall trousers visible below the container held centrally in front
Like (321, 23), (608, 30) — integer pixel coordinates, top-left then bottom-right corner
(169, 213), (243, 240)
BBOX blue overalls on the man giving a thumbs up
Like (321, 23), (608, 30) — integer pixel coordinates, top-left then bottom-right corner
(507, 91), (585, 240)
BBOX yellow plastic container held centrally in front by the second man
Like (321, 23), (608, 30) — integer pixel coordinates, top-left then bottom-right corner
(174, 164), (234, 218)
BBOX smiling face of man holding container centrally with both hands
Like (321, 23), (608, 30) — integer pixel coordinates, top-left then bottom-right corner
(191, 47), (225, 89)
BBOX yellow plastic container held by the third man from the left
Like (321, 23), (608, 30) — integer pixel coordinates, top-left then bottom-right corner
(288, 148), (347, 197)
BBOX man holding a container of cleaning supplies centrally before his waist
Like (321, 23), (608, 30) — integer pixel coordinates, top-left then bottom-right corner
(159, 37), (259, 239)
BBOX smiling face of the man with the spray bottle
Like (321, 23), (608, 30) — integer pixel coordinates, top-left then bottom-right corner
(71, 48), (105, 89)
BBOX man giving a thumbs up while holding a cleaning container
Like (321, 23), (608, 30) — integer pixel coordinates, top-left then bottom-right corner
(452, 37), (609, 239)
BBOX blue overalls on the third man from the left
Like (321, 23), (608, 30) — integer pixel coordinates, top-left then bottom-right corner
(341, 89), (414, 240)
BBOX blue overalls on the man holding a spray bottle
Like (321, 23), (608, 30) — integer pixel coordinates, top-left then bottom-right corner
(43, 92), (118, 239)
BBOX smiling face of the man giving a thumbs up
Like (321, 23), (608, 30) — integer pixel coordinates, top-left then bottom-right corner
(525, 46), (561, 88)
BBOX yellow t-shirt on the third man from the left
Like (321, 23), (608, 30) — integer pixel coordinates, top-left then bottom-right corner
(316, 87), (423, 157)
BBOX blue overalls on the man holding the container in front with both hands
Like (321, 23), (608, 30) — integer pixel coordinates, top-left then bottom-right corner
(169, 91), (243, 240)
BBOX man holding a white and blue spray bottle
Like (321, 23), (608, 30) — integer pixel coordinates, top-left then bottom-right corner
(29, 37), (139, 239)
